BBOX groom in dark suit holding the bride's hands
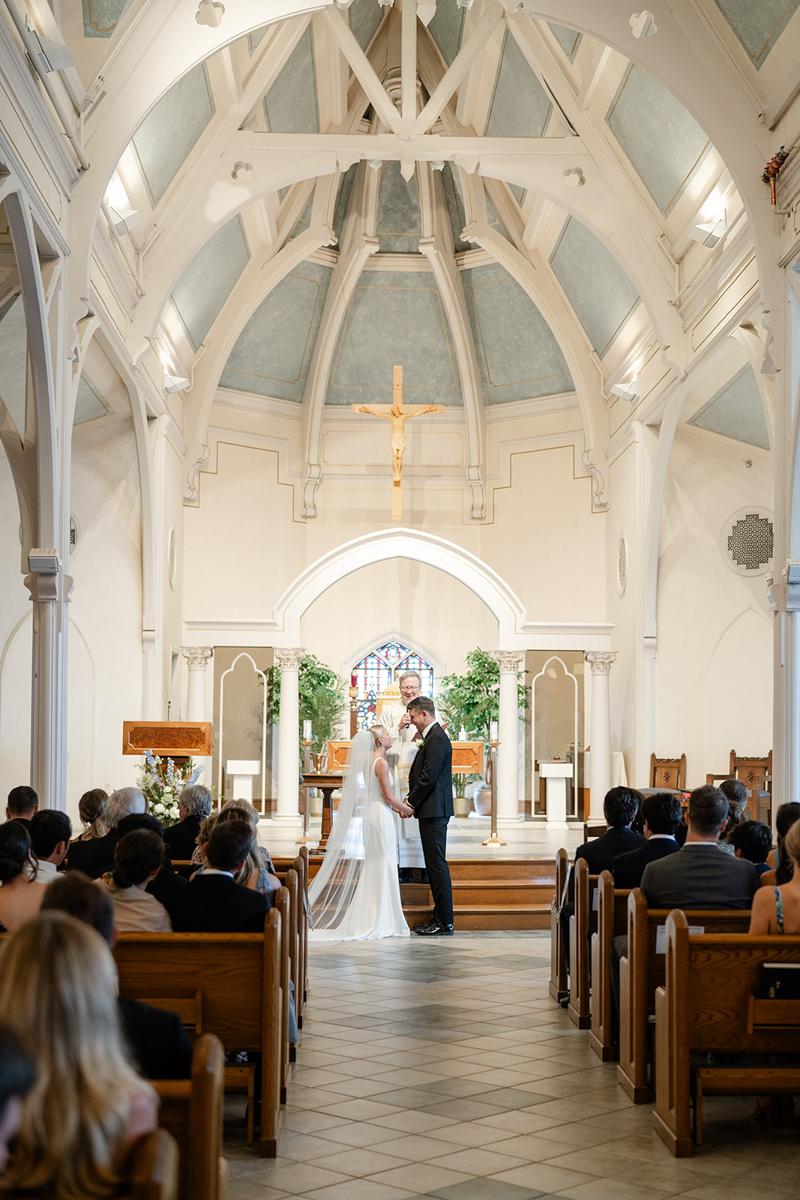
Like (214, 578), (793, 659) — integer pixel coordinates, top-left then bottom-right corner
(405, 696), (453, 937)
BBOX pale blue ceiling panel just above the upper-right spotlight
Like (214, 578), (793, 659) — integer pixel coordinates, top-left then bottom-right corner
(606, 63), (714, 216)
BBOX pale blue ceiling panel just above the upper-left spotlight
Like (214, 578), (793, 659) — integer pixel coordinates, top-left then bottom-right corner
(131, 62), (215, 208)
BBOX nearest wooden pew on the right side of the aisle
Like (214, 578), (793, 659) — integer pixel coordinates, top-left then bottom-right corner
(652, 910), (800, 1158)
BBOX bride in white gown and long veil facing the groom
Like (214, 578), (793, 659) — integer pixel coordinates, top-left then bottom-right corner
(308, 725), (414, 942)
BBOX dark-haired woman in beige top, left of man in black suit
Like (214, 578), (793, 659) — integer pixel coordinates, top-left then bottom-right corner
(97, 829), (173, 934)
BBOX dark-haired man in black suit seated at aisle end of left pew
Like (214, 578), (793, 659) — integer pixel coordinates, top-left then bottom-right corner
(164, 821), (270, 934)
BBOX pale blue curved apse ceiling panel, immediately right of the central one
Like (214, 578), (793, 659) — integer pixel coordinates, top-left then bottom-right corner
(462, 264), (575, 404)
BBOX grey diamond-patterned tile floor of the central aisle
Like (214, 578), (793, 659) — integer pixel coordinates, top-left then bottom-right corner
(225, 932), (800, 1200)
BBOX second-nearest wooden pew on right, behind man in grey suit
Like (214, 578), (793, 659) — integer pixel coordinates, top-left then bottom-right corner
(616, 888), (750, 1104)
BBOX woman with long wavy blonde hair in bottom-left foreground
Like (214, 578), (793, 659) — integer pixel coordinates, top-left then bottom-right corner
(0, 912), (158, 1200)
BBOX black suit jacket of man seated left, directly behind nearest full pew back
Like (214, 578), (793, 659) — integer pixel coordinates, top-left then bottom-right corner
(163, 872), (270, 934)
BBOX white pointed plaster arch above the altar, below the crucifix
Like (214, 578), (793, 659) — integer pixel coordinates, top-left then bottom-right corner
(275, 527), (525, 649)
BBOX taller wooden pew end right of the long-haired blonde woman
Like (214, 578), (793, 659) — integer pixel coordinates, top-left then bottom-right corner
(150, 1033), (228, 1200)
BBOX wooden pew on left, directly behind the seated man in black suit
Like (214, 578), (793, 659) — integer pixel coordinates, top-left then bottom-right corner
(114, 908), (283, 1158)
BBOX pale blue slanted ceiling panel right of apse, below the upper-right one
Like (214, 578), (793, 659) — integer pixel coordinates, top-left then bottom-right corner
(549, 217), (640, 358)
